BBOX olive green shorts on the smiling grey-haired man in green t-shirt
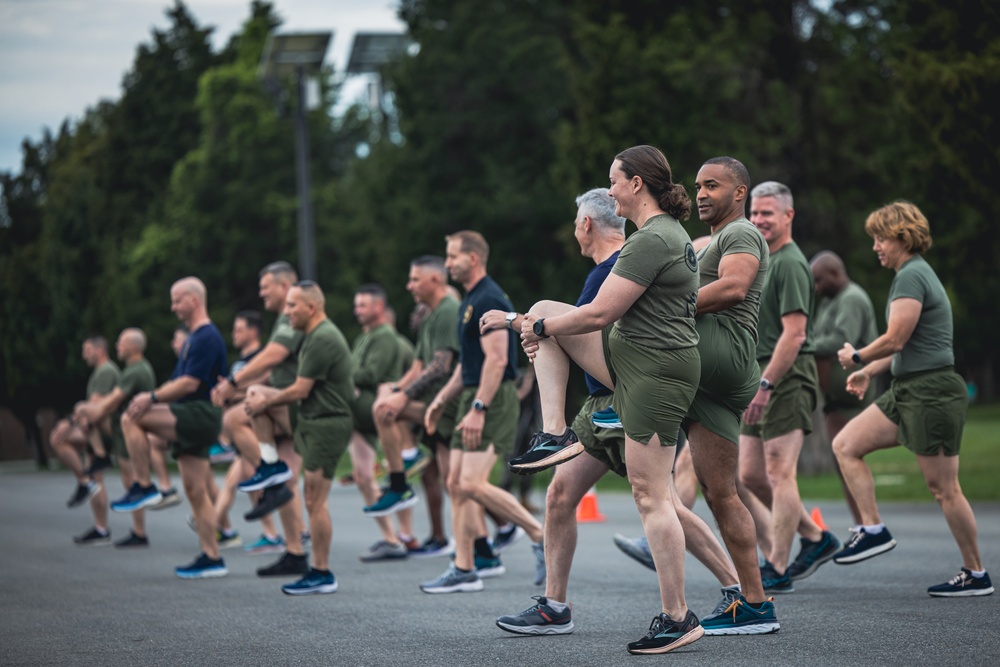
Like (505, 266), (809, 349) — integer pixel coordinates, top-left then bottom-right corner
(740, 354), (819, 440)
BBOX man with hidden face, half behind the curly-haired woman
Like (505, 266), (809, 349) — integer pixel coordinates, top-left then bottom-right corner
(812, 250), (878, 532)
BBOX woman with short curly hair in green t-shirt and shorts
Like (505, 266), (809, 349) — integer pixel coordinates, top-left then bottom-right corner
(833, 201), (993, 597)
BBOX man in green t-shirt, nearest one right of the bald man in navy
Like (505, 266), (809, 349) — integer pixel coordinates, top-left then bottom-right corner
(245, 280), (354, 595)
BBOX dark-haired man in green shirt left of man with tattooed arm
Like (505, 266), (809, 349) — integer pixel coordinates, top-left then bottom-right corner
(350, 283), (419, 563)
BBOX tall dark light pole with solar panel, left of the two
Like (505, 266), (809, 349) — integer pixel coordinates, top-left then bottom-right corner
(258, 32), (333, 280)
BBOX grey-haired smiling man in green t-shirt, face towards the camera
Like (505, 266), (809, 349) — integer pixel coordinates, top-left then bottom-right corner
(740, 181), (840, 593)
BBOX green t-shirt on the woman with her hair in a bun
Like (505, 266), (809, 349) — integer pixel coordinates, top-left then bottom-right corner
(611, 214), (698, 350)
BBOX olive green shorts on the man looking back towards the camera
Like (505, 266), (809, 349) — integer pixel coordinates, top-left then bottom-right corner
(688, 313), (760, 444)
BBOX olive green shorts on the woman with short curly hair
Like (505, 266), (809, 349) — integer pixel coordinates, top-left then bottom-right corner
(875, 366), (969, 456)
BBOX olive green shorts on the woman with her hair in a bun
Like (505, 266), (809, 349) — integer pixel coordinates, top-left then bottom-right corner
(602, 328), (701, 447)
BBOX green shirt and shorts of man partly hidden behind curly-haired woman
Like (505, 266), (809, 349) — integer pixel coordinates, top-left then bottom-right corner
(813, 282), (878, 404)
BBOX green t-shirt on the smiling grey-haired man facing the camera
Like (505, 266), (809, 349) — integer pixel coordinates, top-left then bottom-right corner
(757, 241), (816, 359)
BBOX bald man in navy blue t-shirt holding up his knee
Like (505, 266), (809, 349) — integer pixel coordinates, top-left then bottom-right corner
(111, 276), (229, 579)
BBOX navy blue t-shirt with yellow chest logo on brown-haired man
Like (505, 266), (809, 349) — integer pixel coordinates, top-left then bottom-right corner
(458, 276), (517, 387)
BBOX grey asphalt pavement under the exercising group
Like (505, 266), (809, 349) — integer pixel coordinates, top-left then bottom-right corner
(0, 470), (1000, 667)
